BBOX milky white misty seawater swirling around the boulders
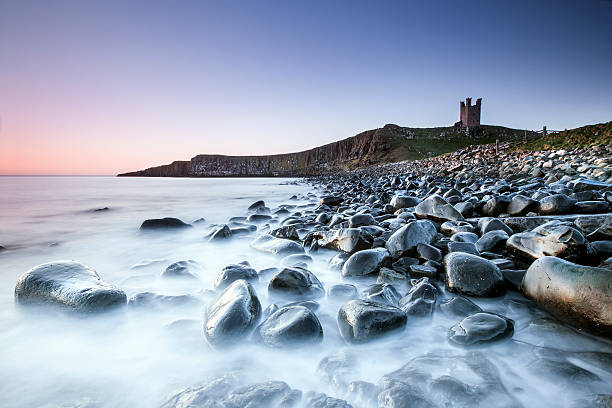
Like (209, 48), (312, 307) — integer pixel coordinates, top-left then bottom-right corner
(0, 177), (612, 407)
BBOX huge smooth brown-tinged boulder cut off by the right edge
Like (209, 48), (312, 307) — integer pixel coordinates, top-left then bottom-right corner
(521, 256), (612, 337)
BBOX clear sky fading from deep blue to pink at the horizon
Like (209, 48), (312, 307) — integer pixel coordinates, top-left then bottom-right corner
(0, 0), (612, 175)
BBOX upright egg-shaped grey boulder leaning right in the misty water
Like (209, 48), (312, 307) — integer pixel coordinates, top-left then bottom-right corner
(204, 280), (261, 347)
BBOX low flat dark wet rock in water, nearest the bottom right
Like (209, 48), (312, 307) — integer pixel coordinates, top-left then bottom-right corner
(448, 312), (514, 346)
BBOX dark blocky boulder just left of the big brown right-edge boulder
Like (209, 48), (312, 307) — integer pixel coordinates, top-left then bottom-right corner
(442, 252), (506, 297)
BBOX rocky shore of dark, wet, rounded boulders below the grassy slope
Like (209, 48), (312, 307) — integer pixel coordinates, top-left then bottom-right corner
(15, 144), (612, 408)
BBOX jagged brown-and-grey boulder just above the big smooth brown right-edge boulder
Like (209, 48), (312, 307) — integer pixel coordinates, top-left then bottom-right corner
(506, 221), (587, 260)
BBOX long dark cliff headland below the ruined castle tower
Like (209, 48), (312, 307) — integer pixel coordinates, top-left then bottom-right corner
(119, 125), (524, 177)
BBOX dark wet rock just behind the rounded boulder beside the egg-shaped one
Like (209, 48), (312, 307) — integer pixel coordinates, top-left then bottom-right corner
(268, 267), (325, 300)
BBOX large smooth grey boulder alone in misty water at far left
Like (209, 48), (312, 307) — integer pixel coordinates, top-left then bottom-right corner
(15, 261), (127, 312)
